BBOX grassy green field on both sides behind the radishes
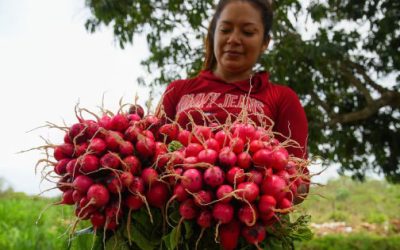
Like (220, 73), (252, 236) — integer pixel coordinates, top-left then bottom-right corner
(0, 177), (400, 250)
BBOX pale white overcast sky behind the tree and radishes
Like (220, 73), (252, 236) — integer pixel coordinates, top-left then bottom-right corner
(0, 0), (344, 196)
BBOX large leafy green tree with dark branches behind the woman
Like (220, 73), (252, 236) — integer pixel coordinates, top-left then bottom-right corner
(86, 0), (400, 182)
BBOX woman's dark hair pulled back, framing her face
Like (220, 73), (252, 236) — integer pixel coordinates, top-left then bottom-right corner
(203, 0), (273, 70)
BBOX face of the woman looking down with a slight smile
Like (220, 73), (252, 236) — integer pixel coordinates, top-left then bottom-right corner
(214, 1), (268, 78)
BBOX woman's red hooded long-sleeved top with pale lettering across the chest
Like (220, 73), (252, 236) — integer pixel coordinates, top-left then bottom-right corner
(158, 71), (308, 158)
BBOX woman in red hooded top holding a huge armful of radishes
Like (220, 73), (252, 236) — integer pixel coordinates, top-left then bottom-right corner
(158, 0), (308, 158)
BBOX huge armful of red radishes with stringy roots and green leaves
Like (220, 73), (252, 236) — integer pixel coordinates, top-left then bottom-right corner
(32, 102), (309, 249)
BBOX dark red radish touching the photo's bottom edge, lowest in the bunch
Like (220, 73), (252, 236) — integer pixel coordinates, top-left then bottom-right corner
(219, 219), (240, 250)
